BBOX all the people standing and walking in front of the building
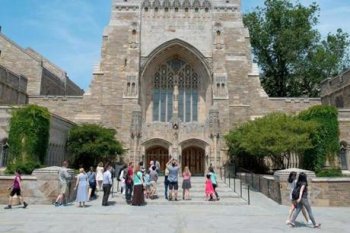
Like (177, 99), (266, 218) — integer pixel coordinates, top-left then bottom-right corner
(5, 159), (321, 228)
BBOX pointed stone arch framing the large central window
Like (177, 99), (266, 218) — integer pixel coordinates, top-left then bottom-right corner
(139, 39), (212, 123)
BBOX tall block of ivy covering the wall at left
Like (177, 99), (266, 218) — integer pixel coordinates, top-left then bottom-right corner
(6, 105), (50, 174)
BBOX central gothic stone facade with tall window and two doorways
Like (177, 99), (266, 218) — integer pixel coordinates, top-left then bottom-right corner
(30, 0), (320, 174)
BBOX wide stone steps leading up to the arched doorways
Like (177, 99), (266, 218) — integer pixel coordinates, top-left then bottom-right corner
(110, 176), (247, 205)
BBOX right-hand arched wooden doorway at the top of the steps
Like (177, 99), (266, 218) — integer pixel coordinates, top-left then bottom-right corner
(181, 146), (205, 176)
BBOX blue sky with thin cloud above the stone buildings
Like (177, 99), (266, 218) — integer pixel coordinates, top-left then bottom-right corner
(0, 0), (350, 90)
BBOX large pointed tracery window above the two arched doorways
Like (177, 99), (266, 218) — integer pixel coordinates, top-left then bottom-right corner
(152, 58), (199, 122)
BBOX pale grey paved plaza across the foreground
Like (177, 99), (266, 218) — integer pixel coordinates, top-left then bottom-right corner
(0, 187), (350, 233)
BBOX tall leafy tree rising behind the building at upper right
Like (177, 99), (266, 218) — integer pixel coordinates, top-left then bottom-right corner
(243, 0), (350, 97)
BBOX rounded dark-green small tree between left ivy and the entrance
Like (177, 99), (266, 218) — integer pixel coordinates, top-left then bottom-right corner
(67, 124), (124, 168)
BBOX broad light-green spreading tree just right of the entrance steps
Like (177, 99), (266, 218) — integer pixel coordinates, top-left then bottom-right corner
(225, 113), (316, 169)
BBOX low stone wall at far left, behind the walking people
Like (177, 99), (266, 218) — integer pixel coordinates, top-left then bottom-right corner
(0, 167), (76, 204)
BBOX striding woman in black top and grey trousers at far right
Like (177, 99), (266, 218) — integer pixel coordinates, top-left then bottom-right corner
(290, 172), (321, 228)
